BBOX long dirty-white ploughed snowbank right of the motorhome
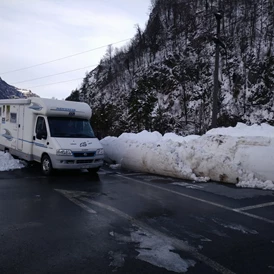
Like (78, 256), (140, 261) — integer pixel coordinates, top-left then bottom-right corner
(101, 123), (274, 190)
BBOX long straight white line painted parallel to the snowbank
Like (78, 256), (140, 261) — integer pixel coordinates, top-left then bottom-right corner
(116, 174), (274, 224)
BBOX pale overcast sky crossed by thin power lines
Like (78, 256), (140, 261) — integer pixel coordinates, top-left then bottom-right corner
(0, 0), (151, 99)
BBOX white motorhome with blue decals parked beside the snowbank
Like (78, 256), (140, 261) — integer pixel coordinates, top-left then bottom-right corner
(0, 97), (104, 175)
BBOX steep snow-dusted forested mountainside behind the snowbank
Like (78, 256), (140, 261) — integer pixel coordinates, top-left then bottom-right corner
(67, 0), (274, 137)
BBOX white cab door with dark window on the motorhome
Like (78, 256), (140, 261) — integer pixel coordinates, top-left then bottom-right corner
(33, 116), (49, 161)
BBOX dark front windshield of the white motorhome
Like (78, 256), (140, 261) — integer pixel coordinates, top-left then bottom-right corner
(48, 117), (95, 138)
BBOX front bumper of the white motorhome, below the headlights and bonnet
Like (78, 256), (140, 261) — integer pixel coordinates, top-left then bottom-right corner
(51, 155), (104, 169)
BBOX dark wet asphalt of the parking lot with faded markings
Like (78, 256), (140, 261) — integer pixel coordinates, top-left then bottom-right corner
(0, 165), (274, 273)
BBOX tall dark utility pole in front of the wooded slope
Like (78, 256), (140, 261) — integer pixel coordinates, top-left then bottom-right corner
(211, 11), (223, 128)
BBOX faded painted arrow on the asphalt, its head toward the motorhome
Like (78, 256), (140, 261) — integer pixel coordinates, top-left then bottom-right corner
(55, 189), (234, 274)
